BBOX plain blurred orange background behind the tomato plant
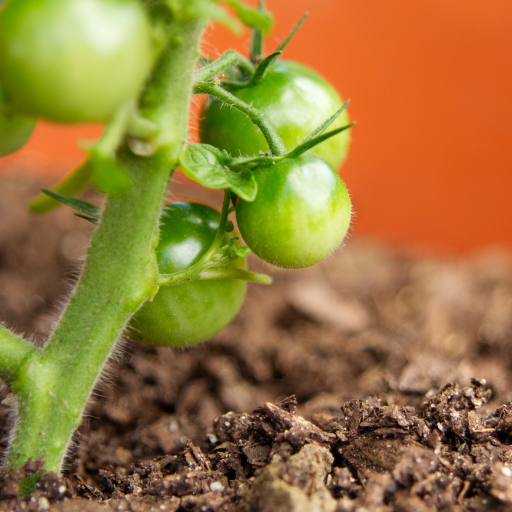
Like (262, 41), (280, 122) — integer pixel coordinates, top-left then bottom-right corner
(0, 0), (512, 252)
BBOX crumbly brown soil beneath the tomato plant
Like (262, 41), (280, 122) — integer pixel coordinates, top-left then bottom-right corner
(0, 176), (512, 512)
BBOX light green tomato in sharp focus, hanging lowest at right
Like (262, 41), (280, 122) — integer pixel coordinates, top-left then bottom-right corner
(236, 153), (351, 268)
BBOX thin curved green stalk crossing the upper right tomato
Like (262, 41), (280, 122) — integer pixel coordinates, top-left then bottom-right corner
(194, 82), (286, 156)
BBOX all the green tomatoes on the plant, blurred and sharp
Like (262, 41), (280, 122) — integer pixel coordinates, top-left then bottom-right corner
(0, 0), (351, 346)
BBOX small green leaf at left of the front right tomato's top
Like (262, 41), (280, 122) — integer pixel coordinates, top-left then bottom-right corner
(180, 144), (258, 201)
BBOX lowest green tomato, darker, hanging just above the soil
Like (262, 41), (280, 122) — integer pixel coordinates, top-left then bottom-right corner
(131, 202), (247, 346)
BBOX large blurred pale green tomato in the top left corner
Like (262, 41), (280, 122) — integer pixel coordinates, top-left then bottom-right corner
(0, 0), (153, 123)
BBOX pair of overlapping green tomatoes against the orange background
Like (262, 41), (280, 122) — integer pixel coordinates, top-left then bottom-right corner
(200, 61), (351, 268)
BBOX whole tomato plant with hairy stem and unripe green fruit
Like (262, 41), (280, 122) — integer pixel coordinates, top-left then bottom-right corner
(0, 0), (351, 482)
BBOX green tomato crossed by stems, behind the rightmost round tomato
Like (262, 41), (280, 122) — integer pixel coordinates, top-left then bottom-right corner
(200, 61), (350, 169)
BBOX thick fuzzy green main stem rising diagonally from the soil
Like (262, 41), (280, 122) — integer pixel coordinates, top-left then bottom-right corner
(8, 20), (204, 471)
